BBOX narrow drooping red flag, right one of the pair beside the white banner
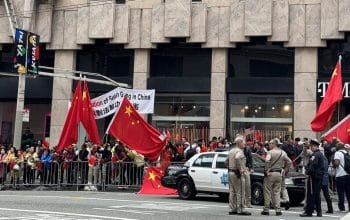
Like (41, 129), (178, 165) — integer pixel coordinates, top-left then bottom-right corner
(81, 81), (101, 144)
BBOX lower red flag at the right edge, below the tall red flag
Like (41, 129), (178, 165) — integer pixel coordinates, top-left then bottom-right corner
(322, 114), (350, 144)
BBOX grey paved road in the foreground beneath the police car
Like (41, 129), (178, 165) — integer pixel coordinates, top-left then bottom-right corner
(0, 191), (350, 220)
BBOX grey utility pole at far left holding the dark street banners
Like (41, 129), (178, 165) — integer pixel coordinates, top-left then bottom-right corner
(4, 0), (35, 148)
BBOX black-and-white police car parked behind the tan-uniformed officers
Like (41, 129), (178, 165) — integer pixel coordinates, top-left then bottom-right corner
(161, 151), (305, 205)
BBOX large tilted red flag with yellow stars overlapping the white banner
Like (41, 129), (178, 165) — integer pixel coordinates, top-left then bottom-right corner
(107, 97), (166, 161)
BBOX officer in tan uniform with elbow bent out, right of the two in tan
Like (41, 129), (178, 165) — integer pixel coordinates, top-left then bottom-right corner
(261, 138), (292, 215)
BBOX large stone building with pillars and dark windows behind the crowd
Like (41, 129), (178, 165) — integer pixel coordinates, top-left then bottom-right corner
(0, 0), (350, 148)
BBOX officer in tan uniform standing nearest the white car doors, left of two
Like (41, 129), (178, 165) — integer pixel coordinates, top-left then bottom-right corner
(226, 136), (251, 215)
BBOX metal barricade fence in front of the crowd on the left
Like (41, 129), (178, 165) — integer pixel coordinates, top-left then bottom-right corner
(0, 161), (183, 191)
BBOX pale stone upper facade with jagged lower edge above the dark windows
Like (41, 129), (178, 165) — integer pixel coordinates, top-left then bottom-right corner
(0, 0), (350, 50)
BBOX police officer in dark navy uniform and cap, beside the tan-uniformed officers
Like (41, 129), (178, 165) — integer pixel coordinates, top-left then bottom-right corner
(300, 139), (324, 217)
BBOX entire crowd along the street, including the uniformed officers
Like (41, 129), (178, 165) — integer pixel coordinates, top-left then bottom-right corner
(0, 131), (350, 217)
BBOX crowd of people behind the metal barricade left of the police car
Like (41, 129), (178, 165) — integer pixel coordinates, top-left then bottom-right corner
(0, 141), (145, 190)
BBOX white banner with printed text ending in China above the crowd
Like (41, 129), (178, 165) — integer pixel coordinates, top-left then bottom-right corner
(91, 87), (155, 119)
